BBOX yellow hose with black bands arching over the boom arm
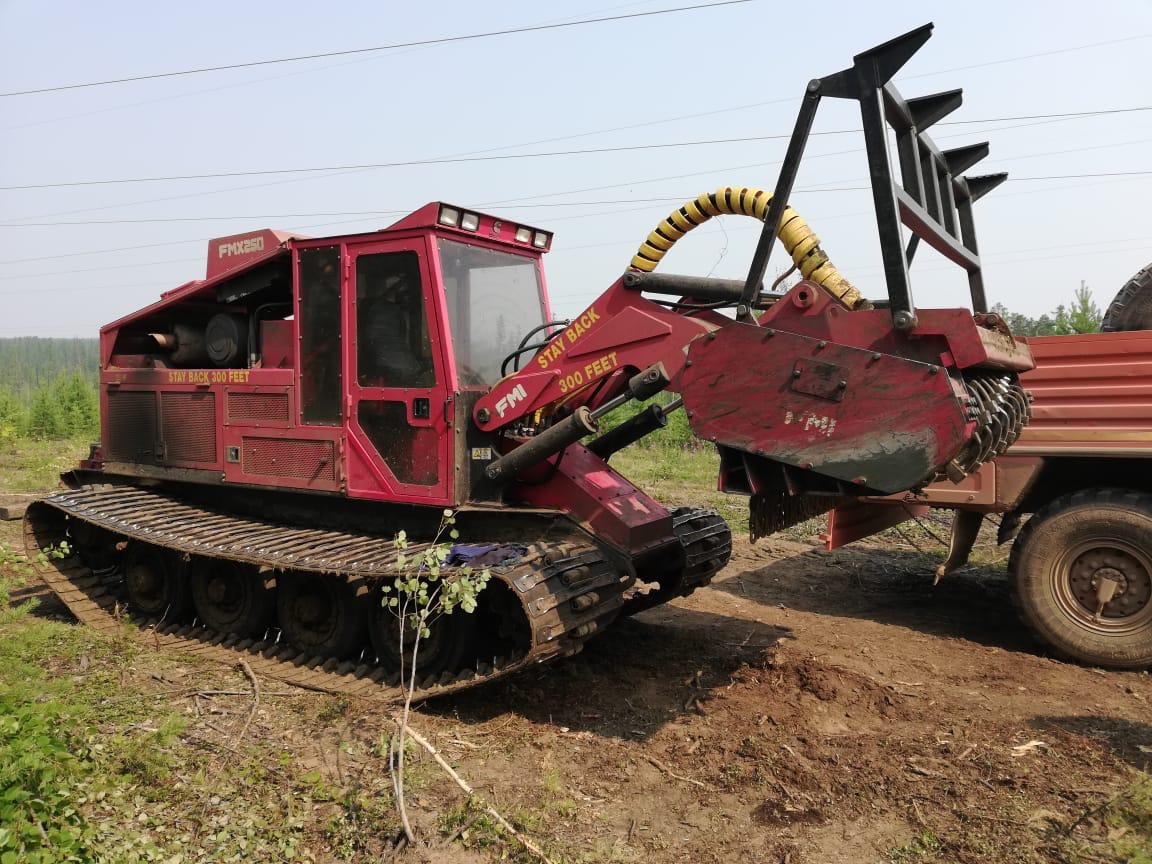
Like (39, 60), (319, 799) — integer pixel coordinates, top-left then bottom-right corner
(630, 187), (863, 309)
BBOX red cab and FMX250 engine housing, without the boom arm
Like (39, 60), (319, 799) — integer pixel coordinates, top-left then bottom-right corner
(100, 204), (551, 506)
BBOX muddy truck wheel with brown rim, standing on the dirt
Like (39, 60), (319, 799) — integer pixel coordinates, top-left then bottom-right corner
(1008, 488), (1152, 669)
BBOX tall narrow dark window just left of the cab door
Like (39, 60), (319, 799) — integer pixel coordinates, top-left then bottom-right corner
(300, 247), (342, 424)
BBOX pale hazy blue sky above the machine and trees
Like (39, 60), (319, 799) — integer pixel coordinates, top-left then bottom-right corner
(0, 0), (1152, 336)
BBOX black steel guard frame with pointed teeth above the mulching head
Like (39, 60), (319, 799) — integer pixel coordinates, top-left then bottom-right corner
(741, 23), (1008, 331)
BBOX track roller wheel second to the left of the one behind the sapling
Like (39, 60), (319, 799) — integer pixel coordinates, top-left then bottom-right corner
(189, 558), (275, 636)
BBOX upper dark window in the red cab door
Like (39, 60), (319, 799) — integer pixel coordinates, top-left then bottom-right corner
(356, 252), (435, 387)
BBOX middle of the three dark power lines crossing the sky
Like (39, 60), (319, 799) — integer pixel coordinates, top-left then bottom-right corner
(0, 105), (1152, 191)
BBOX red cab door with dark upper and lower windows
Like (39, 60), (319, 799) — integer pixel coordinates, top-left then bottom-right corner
(346, 237), (452, 503)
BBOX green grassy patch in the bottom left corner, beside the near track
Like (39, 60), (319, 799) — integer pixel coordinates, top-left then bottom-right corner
(0, 585), (334, 864)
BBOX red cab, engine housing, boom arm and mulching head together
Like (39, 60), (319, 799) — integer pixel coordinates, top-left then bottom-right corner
(100, 203), (1028, 569)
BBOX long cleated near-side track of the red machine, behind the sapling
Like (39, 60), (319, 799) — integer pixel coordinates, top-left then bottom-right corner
(24, 486), (630, 702)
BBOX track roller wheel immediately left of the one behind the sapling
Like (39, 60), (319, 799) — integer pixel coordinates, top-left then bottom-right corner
(276, 573), (371, 659)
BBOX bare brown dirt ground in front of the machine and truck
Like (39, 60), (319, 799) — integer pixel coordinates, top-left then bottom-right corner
(8, 511), (1152, 864)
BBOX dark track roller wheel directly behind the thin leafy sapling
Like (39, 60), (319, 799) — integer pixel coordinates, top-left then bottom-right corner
(370, 593), (477, 679)
